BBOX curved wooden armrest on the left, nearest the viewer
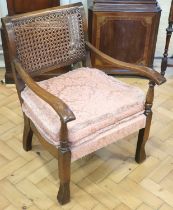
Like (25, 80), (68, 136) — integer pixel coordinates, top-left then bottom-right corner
(13, 59), (76, 123)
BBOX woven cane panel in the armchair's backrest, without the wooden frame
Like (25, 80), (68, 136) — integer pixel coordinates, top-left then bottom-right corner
(12, 4), (85, 75)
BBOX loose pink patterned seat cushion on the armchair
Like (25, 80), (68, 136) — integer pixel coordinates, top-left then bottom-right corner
(21, 68), (145, 146)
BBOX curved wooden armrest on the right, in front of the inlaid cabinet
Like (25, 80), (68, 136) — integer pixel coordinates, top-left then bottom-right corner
(86, 42), (166, 85)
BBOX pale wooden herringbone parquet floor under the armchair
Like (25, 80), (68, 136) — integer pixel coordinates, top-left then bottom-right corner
(0, 64), (173, 210)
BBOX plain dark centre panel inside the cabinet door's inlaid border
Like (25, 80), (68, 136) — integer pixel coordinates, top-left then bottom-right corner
(99, 18), (147, 63)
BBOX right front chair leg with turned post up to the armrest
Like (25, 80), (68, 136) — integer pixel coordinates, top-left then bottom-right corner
(135, 81), (155, 163)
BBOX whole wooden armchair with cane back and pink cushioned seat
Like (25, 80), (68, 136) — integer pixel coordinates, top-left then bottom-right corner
(2, 3), (165, 204)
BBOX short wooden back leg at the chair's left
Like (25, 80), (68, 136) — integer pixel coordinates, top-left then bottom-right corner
(23, 114), (33, 151)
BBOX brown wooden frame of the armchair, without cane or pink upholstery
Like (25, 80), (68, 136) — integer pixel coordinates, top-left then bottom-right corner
(2, 3), (166, 204)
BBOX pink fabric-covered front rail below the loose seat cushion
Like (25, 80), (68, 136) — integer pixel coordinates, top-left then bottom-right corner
(71, 114), (146, 161)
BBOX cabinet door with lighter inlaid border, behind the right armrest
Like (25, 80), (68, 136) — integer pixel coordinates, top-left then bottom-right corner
(90, 12), (159, 68)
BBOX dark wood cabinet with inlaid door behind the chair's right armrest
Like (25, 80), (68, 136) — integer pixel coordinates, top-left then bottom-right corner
(89, 0), (161, 69)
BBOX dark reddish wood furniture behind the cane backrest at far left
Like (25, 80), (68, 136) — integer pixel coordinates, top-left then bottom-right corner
(1, 0), (60, 83)
